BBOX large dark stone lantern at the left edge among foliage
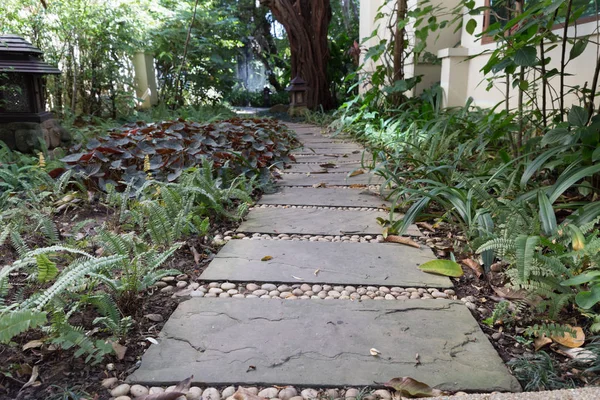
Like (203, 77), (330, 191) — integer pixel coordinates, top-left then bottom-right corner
(0, 35), (68, 151)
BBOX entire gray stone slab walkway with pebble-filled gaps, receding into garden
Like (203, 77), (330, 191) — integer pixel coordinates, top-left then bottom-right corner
(129, 124), (520, 392)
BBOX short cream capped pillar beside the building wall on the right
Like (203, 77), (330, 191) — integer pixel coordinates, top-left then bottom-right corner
(438, 47), (469, 108)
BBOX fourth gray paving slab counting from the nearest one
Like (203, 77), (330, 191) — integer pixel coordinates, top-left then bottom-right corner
(258, 187), (390, 207)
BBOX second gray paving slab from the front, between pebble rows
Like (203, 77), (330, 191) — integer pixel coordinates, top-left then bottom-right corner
(200, 240), (453, 288)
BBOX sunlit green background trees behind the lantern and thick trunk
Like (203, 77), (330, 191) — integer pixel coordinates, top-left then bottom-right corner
(0, 0), (358, 118)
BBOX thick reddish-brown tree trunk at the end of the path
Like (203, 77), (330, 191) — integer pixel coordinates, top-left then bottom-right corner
(260, 0), (333, 110)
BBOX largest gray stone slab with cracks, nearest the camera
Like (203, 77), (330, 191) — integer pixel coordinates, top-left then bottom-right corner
(128, 298), (520, 391)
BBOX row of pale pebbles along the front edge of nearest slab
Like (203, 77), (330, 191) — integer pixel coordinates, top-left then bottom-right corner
(102, 378), (426, 400)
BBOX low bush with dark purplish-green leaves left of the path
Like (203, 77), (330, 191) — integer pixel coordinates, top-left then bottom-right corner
(62, 118), (296, 188)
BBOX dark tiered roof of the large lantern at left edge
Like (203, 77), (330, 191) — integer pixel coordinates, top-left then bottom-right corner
(0, 35), (60, 74)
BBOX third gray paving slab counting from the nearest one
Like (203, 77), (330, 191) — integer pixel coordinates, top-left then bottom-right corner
(238, 208), (421, 236)
